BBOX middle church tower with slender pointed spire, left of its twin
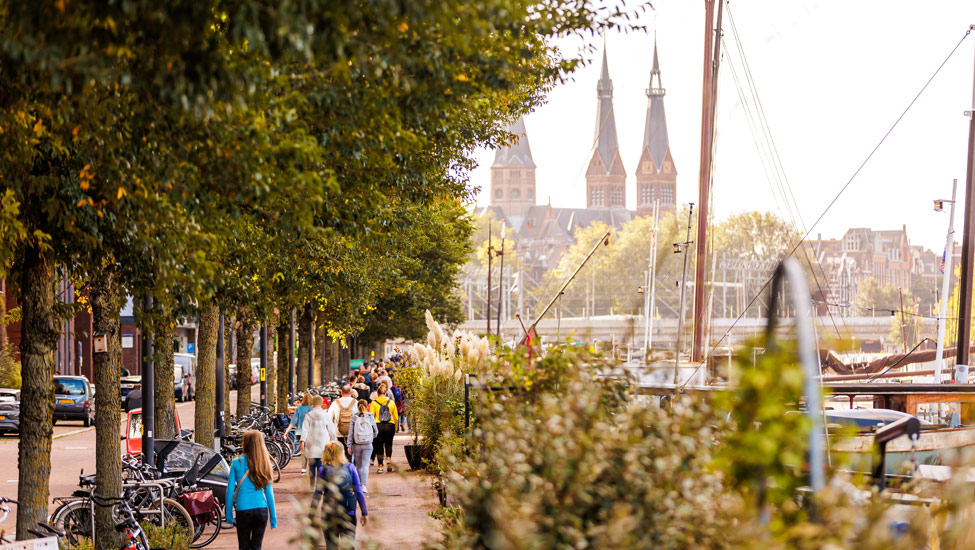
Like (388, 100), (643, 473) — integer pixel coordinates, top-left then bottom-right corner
(586, 46), (626, 208)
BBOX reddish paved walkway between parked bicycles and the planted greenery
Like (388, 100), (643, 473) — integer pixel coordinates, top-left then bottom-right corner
(207, 435), (439, 550)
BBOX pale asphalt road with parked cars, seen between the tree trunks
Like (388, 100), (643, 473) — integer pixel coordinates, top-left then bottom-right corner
(0, 391), (246, 533)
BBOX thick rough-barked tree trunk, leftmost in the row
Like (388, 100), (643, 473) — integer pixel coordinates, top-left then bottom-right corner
(17, 243), (57, 540)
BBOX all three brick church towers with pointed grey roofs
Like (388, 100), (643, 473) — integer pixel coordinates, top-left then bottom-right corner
(490, 41), (677, 218)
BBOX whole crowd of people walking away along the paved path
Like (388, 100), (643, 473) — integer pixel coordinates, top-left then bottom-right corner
(226, 368), (404, 550)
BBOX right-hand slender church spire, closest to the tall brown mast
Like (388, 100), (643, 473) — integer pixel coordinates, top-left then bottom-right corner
(636, 40), (677, 215)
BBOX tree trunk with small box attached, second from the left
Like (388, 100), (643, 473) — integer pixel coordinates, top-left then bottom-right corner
(89, 268), (122, 550)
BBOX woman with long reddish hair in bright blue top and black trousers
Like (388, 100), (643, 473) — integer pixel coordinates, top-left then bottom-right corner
(226, 430), (278, 550)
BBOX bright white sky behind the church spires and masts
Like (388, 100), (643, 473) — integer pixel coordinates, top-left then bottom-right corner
(471, 0), (975, 252)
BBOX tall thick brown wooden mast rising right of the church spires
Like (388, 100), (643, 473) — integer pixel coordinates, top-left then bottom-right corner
(691, 0), (724, 362)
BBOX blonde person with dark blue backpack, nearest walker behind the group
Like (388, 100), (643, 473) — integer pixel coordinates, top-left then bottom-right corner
(312, 441), (369, 549)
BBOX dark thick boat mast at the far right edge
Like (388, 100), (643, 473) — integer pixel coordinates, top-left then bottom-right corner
(955, 25), (975, 378)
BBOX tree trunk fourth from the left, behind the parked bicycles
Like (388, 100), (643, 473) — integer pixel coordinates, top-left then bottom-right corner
(193, 302), (220, 448)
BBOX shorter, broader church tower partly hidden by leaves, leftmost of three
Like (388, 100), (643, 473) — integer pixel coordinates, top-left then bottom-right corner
(490, 117), (535, 216)
